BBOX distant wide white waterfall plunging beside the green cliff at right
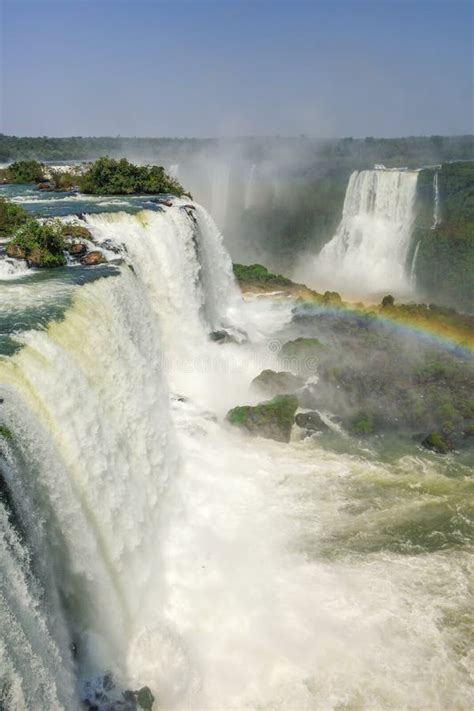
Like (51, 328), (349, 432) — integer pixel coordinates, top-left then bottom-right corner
(298, 169), (418, 296)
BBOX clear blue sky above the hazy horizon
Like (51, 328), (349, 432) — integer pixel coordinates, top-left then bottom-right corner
(0, 0), (473, 137)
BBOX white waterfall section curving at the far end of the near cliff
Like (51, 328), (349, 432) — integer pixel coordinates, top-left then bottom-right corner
(87, 201), (240, 354)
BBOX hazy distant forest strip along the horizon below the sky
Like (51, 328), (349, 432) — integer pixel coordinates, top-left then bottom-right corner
(0, 134), (474, 170)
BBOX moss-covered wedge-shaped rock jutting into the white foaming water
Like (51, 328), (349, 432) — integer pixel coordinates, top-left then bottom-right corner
(227, 395), (298, 442)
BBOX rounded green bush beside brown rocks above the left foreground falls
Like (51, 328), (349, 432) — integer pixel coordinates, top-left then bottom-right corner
(6, 220), (66, 267)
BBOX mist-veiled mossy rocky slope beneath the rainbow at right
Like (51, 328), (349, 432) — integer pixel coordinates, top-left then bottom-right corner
(288, 303), (474, 446)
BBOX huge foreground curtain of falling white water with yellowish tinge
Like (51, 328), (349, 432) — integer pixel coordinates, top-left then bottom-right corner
(0, 270), (175, 708)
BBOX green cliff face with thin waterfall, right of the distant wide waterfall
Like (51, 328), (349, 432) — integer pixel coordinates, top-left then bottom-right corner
(412, 162), (474, 312)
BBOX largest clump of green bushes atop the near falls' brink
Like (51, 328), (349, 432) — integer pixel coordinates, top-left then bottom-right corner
(78, 156), (184, 195)
